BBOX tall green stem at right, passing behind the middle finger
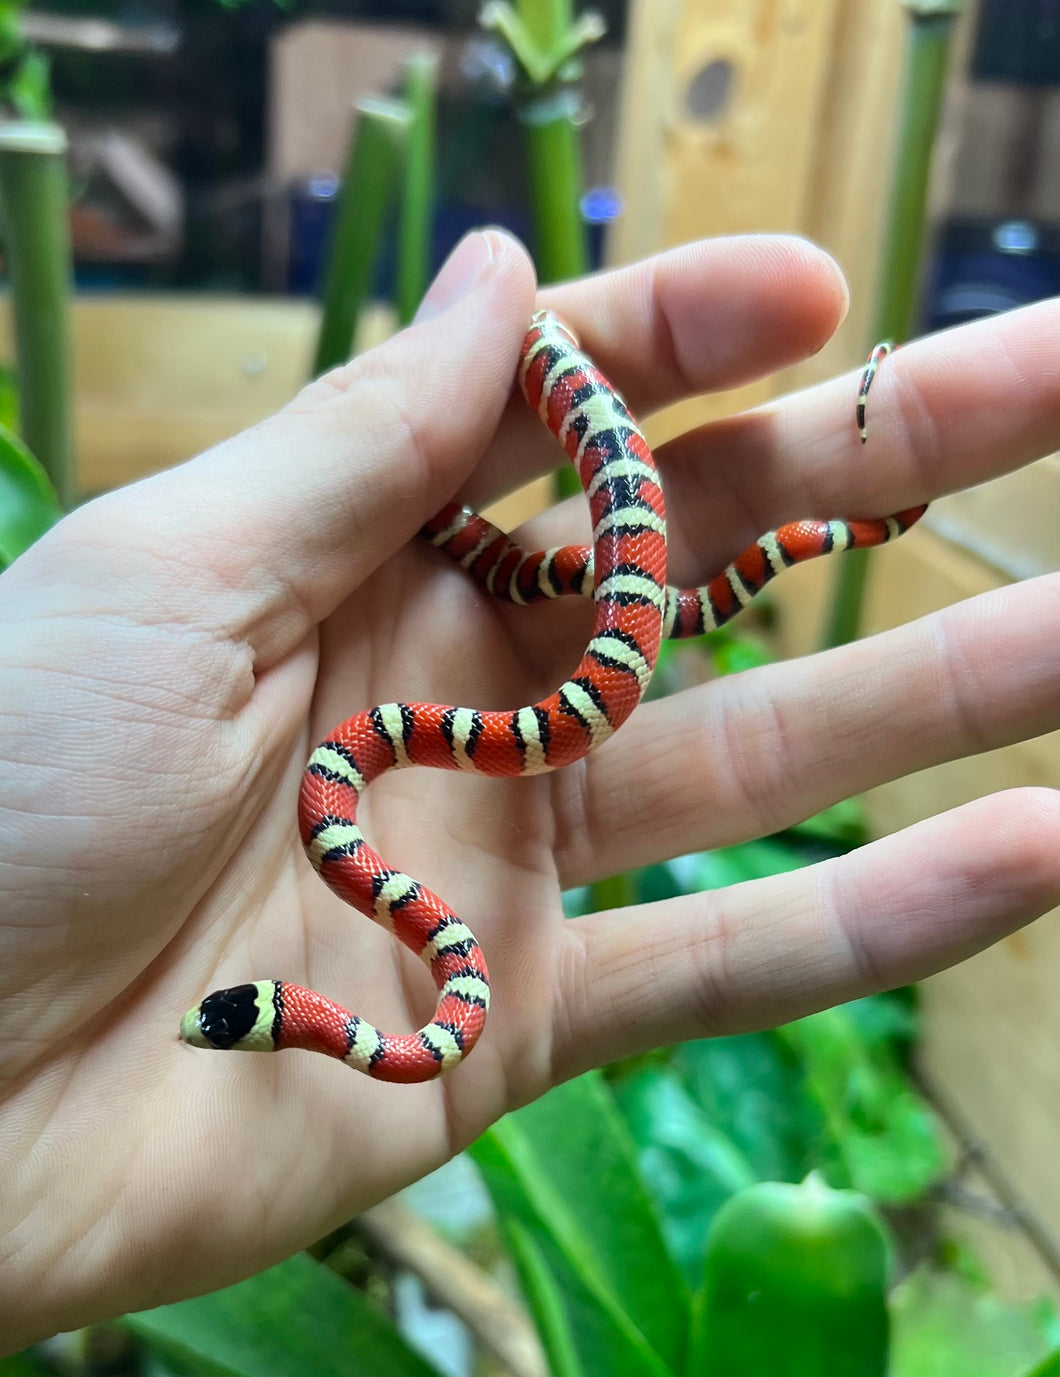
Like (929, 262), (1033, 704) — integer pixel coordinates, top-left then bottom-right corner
(823, 0), (960, 647)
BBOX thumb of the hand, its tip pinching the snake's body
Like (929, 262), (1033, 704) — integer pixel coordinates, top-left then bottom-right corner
(66, 231), (534, 669)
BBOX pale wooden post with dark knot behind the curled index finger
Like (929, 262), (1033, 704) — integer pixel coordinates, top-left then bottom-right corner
(608, 0), (870, 442)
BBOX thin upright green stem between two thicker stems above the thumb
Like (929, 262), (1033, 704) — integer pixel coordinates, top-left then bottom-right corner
(396, 52), (438, 325)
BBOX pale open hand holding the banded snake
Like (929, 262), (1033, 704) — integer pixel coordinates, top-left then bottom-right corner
(0, 231), (1060, 1351)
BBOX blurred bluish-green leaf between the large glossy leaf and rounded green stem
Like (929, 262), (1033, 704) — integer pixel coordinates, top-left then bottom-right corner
(610, 1066), (757, 1286)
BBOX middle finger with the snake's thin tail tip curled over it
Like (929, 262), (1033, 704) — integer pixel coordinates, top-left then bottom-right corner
(655, 300), (1060, 582)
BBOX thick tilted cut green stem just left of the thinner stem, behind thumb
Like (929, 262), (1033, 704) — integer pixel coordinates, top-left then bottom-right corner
(312, 99), (412, 376)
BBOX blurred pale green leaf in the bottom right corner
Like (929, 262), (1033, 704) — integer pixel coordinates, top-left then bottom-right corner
(891, 1265), (1056, 1377)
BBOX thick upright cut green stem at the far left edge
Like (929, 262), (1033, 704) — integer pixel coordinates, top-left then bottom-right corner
(0, 121), (77, 507)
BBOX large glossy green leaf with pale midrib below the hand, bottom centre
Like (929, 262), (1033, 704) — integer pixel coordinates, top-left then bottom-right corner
(471, 1073), (690, 1377)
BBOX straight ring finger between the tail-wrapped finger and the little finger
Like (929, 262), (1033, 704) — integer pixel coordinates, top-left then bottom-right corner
(553, 574), (1060, 887)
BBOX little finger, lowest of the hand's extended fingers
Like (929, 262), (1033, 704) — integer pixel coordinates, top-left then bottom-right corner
(552, 789), (1060, 1081)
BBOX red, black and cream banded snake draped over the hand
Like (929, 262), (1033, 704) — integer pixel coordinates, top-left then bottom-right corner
(180, 319), (925, 1084)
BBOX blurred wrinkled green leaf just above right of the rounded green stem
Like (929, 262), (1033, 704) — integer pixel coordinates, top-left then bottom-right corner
(778, 1005), (946, 1203)
